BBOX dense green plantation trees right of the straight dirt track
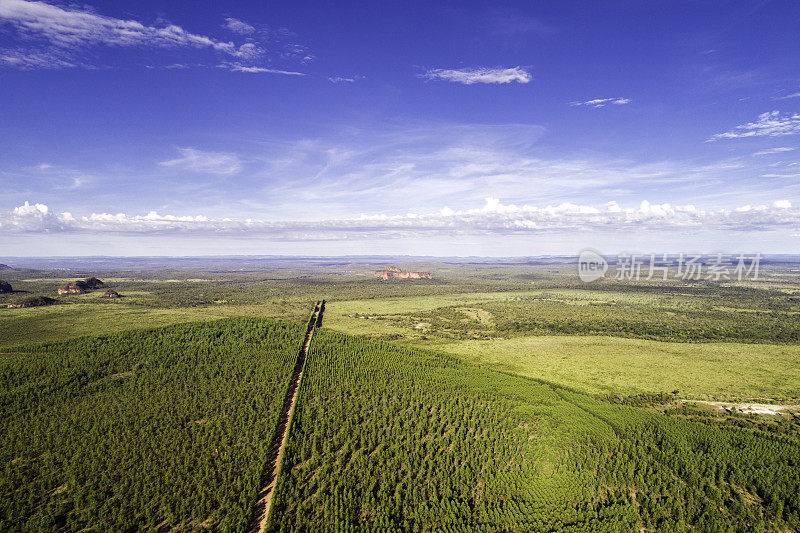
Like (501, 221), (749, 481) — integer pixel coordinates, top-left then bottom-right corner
(270, 332), (800, 531)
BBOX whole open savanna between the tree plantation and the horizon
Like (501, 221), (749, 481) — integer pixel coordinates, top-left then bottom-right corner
(0, 264), (800, 399)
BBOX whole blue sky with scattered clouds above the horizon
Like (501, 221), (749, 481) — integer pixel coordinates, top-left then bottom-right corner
(0, 0), (800, 256)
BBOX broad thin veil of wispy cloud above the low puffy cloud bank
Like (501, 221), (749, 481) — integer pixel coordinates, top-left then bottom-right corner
(0, 122), (800, 231)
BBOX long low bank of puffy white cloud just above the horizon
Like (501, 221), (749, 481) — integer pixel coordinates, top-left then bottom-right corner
(0, 198), (800, 240)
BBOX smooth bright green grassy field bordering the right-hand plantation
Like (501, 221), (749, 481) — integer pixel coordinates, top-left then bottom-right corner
(436, 336), (800, 400)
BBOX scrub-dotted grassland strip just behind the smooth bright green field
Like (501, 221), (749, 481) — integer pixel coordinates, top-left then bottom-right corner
(322, 287), (800, 344)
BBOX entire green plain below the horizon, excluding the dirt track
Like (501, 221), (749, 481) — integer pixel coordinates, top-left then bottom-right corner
(0, 261), (800, 531)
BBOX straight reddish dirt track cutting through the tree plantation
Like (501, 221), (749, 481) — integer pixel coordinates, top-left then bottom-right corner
(248, 300), (325, 533)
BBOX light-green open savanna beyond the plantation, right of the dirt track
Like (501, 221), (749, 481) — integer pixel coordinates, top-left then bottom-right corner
(326, 285), (800, 401)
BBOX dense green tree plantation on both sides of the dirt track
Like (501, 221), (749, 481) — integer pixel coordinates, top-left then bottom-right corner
(0, 306), (800, 532)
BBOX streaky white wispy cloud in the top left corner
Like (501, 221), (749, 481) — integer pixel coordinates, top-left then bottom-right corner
(0, 0), (312, 69)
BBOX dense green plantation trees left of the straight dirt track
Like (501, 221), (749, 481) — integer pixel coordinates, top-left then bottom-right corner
(0, 318), (303, 531)
